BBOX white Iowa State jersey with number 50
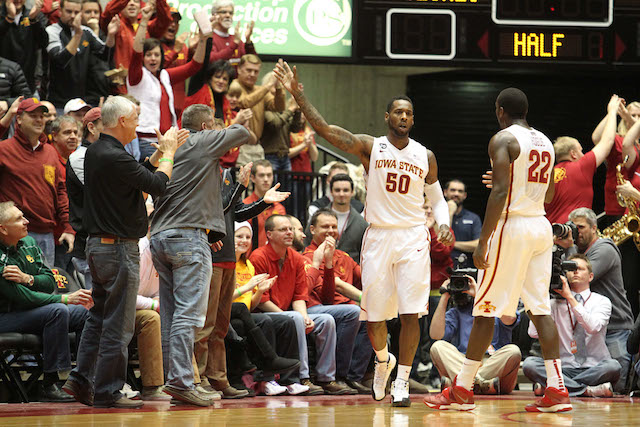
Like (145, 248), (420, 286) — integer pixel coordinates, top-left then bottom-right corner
(364, 136), (429, 228)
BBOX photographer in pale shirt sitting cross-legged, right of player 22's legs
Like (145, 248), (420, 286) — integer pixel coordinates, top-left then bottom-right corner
(522, 254), (621, 397)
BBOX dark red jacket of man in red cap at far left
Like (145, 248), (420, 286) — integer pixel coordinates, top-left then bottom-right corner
(0, 128), (73, 233)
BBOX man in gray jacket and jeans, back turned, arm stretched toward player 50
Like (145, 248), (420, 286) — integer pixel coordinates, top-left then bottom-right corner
(151, 104), (255, 406)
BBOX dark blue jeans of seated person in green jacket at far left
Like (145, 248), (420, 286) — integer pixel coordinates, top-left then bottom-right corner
(0, 303), (89, 372)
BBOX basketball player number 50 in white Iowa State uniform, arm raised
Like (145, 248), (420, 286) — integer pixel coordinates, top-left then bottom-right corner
(274, 62), (453, 406)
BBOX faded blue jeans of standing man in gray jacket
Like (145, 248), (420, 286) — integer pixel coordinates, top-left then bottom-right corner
(151, 228), (213, 390)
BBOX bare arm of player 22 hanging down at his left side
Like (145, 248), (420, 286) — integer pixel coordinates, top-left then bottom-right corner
(473, 132), (520, 269)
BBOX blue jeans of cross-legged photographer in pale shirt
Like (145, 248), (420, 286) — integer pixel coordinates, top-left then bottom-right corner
(522, 356), (620, 396)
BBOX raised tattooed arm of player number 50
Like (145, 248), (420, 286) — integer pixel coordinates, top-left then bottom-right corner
(273, 61), (373, 169)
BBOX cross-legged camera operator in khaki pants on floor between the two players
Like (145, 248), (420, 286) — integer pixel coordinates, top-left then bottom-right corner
(429, 276), (522, 394)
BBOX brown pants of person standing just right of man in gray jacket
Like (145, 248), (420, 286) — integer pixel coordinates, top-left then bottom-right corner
(195, 267), (236, 390)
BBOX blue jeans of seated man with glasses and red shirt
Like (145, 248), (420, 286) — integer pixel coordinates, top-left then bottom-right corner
(265, 311), (336, 381)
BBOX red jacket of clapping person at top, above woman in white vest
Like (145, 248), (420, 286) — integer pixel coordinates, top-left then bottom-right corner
(100, 0), (173, 75)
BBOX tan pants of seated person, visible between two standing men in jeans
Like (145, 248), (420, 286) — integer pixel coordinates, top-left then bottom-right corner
(135, 310), (200, 387)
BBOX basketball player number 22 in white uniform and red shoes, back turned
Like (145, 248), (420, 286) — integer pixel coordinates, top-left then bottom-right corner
(425, 88), (572, 412)
